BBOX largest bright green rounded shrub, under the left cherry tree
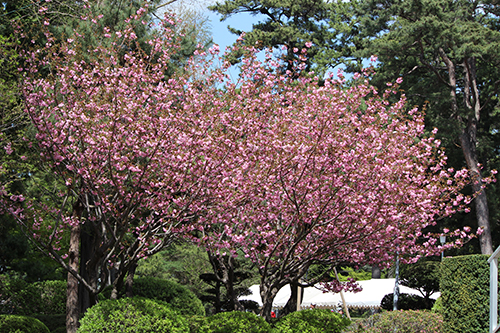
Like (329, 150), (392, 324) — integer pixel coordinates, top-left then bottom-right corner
(78, 297), (189, 333)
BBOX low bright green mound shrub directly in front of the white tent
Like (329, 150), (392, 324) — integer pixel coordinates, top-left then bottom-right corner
(275, 309), (351, 333)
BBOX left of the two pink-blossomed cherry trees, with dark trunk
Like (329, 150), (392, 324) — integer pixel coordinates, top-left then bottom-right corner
(1, 7), (227, 332)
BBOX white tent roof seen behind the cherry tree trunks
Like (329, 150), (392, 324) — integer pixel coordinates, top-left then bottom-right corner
(240, 279), (439, 308)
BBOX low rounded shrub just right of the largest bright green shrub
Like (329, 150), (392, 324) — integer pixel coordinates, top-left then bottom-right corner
(198, 311), (271, 333)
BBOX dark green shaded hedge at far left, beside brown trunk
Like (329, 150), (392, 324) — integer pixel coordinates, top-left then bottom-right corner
(0, 276), (66, 315)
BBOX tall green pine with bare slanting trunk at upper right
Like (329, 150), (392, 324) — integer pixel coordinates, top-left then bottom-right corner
(357, 0), (500, 253)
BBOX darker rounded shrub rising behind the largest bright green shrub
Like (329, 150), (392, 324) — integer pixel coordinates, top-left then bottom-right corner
(132, 277), (205, 316)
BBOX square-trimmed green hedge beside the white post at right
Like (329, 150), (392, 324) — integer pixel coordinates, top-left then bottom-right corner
(440, 255), (490, 333)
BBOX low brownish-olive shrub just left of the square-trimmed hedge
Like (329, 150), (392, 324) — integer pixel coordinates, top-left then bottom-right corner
(349, 310), (443, 333)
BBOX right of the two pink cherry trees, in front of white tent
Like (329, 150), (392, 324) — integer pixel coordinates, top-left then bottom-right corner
(192, 50), (492, 320)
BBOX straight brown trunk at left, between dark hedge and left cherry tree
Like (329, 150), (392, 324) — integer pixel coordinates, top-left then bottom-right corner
(66, 223), (81, 333)
